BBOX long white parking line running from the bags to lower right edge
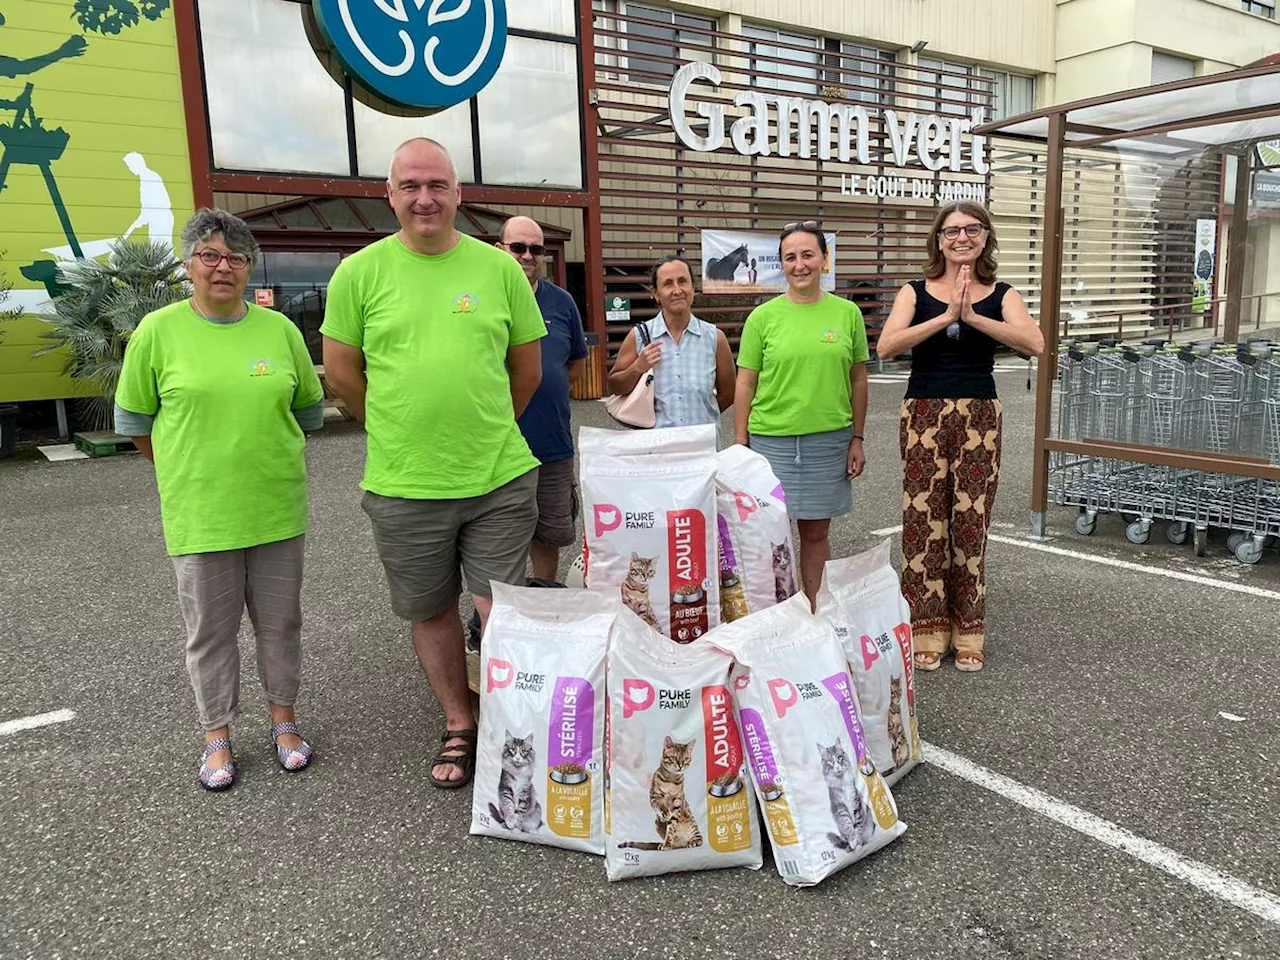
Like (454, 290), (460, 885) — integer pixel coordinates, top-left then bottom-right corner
(924, 744), (1280, 925)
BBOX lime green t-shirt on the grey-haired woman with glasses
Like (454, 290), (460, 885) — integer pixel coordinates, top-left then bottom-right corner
(115, 301), (324, 557)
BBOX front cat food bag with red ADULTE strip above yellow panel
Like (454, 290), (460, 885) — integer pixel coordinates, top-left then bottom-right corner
(604, 611), (762, 881)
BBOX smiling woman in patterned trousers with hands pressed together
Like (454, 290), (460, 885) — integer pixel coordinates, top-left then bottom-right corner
(877, 202), (1044, 672)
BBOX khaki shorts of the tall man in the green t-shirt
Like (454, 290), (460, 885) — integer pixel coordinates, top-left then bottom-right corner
(360, 470), (538, 621)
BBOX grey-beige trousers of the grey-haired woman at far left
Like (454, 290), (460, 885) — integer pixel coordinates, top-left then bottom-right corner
(173, 536), (306, 730)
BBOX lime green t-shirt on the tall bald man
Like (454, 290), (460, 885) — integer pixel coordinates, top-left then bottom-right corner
(320, 236), (547, 500)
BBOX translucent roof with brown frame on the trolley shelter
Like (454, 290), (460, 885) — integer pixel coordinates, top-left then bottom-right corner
(975, 56), (1280, 156)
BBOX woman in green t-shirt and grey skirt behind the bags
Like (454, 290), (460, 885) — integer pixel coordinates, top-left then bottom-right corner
(733, 220), (868, 603)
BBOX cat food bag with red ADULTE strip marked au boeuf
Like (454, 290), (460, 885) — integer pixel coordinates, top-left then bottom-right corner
(579, 424), (719, 644)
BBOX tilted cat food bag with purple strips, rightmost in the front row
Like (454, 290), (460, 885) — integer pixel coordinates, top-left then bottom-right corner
(707, 594), (906, 887)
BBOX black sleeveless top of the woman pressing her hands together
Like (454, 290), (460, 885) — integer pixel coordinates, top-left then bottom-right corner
(906, 280), (1011, 399)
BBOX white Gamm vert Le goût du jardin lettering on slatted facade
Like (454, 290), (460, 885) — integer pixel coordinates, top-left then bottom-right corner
(667, 61), (989, 200)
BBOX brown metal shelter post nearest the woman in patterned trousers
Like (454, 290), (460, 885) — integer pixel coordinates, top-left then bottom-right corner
(1032, 113), (1066, 536)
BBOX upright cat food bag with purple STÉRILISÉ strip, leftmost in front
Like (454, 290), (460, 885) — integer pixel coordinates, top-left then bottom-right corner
(471, 584), (618, 854)
